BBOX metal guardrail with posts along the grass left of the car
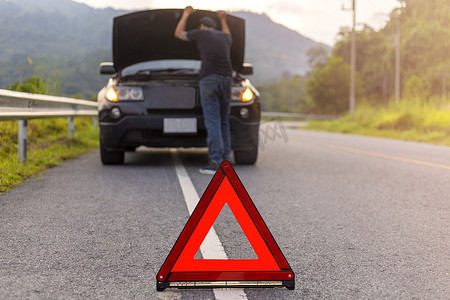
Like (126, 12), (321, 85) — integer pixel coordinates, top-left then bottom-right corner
(0, 89), (98, 161)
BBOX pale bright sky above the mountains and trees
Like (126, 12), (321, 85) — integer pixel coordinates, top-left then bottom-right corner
(74, 0), (399, 46)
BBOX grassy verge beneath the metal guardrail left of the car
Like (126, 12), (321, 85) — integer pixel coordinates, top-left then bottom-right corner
(0, 117), (98, 194)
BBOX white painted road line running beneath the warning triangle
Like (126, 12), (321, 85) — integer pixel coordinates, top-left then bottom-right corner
(170, 149), (247, 300)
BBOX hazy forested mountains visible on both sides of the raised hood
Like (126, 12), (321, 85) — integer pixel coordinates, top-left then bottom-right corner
(0, 0), (330, 97)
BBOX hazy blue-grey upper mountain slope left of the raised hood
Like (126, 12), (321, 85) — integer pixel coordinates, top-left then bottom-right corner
(0, 0), (125, 60)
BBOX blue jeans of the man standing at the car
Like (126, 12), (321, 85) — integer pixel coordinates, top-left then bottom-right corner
(200, 74), (232, 163)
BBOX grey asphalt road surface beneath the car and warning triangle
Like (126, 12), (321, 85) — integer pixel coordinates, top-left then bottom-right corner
(0, 122), (450, 299)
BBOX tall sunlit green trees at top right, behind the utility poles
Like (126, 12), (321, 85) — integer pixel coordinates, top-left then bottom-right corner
(326, 0), (450, 102)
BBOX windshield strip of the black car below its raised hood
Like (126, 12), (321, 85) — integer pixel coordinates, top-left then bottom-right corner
(122, 59), (200, 77)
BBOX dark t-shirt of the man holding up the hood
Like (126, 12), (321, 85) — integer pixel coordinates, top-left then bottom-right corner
(187, 29), (233, 78)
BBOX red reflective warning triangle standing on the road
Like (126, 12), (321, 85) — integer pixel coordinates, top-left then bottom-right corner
(156, 161), (295, 291)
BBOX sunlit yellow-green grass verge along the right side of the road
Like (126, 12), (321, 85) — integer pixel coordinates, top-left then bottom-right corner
(303, 99), (450, 145)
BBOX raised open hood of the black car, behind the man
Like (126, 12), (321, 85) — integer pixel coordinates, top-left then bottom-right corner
(113, 9), (245, 72)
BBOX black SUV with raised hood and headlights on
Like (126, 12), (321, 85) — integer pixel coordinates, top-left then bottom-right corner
(98, 9), (261, 164)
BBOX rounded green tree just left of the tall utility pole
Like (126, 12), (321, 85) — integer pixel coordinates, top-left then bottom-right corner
(306, 56), (363, 114)
